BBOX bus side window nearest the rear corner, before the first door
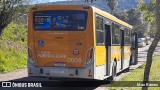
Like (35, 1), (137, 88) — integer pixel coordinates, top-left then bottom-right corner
(96, 16), (105, 46)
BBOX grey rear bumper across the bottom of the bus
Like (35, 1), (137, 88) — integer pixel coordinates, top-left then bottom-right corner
(28, 63), (94, 79)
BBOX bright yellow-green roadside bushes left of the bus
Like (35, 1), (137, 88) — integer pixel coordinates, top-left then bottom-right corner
(0, 22), (27, 73)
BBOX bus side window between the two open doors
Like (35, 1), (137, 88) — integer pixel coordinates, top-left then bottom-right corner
(112, 23), (120, 45)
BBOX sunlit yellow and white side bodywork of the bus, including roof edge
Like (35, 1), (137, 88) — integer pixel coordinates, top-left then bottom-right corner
(93, 8), (132, 80)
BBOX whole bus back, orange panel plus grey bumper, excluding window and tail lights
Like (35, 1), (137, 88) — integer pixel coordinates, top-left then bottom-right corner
(28, 5), (94, 79)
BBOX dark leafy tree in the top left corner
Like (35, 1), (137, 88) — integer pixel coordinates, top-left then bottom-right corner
(0, 0), (38, 37)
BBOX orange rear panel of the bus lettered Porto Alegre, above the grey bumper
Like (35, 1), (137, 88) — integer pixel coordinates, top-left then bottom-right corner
(28, 5), (93, 67)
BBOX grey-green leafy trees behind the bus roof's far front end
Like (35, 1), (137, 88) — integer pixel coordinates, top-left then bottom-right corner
(113, 9), (148, 38)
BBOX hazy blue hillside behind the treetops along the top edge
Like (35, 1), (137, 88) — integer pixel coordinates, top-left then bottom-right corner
(45, 0), (150, 11)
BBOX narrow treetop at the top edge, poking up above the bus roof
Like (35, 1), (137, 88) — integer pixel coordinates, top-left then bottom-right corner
(106, 0), (118, 14)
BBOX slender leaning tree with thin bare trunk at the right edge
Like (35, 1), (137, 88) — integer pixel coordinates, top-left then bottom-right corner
(139, 0), (160, 90)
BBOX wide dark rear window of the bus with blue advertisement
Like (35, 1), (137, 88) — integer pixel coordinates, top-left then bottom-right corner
(33, 10), (88, 31)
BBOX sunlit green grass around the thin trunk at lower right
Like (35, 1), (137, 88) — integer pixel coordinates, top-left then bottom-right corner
(108, 55), (160, 90)
